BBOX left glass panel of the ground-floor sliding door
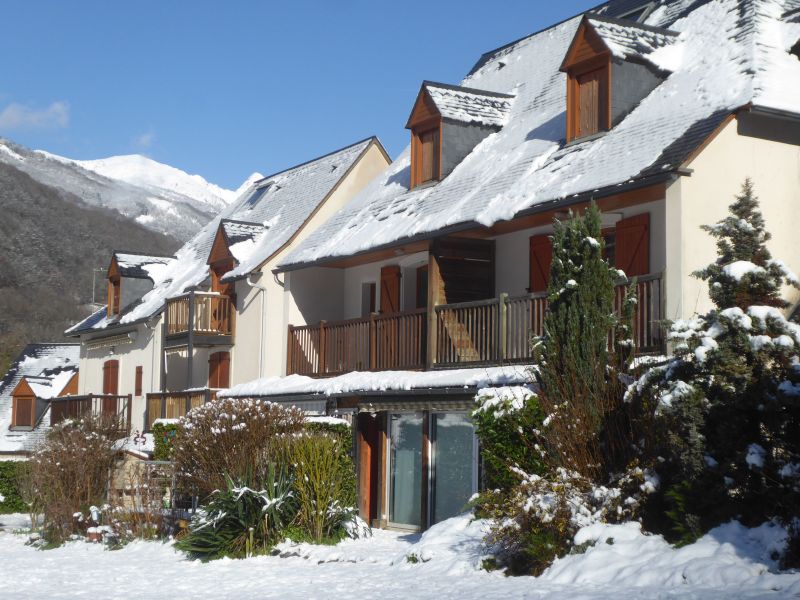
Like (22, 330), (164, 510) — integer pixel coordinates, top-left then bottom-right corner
(389, 413), (423, 527)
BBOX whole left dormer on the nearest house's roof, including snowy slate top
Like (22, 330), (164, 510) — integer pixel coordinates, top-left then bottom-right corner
(406, 81), (513, 188)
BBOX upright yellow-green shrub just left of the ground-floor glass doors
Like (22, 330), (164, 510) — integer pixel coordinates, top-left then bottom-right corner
(281, 432), (357, 542)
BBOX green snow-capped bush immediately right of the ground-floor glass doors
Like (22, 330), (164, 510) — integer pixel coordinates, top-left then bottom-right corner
(472, 386), (545, 492)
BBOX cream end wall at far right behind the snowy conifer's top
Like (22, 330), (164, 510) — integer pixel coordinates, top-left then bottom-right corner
(666, 114), (800, 319)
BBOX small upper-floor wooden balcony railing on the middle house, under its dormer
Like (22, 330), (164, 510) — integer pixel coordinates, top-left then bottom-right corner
(166, 292), (233, 336)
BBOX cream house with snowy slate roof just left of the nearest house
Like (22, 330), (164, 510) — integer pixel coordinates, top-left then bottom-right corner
(67, 137), (389, 430)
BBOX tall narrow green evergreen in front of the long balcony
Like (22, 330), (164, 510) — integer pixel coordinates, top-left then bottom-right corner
(535, 204), (632, 481)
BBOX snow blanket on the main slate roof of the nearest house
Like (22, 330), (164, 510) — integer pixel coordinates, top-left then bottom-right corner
(280, 0), (800, 269)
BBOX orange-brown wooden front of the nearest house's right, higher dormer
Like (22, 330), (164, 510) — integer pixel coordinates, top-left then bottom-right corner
(561, 21), (611, 142)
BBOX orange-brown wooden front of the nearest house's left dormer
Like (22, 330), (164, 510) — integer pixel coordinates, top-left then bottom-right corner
(406, 89), (442, 188)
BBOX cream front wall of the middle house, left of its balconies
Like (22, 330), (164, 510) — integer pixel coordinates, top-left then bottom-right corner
(78, 315), (163, 430)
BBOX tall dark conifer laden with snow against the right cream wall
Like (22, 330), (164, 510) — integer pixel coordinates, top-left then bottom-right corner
(628, 180), (800, 542)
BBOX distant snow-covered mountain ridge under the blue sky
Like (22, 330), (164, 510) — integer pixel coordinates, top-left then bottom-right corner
(0, 138), (261, 240)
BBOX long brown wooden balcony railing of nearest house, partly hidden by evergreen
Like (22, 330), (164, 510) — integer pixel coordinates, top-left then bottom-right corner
(286, 275), (664, 377)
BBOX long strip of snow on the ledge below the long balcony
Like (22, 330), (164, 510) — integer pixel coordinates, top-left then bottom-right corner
(217, 365), (531, 398)
